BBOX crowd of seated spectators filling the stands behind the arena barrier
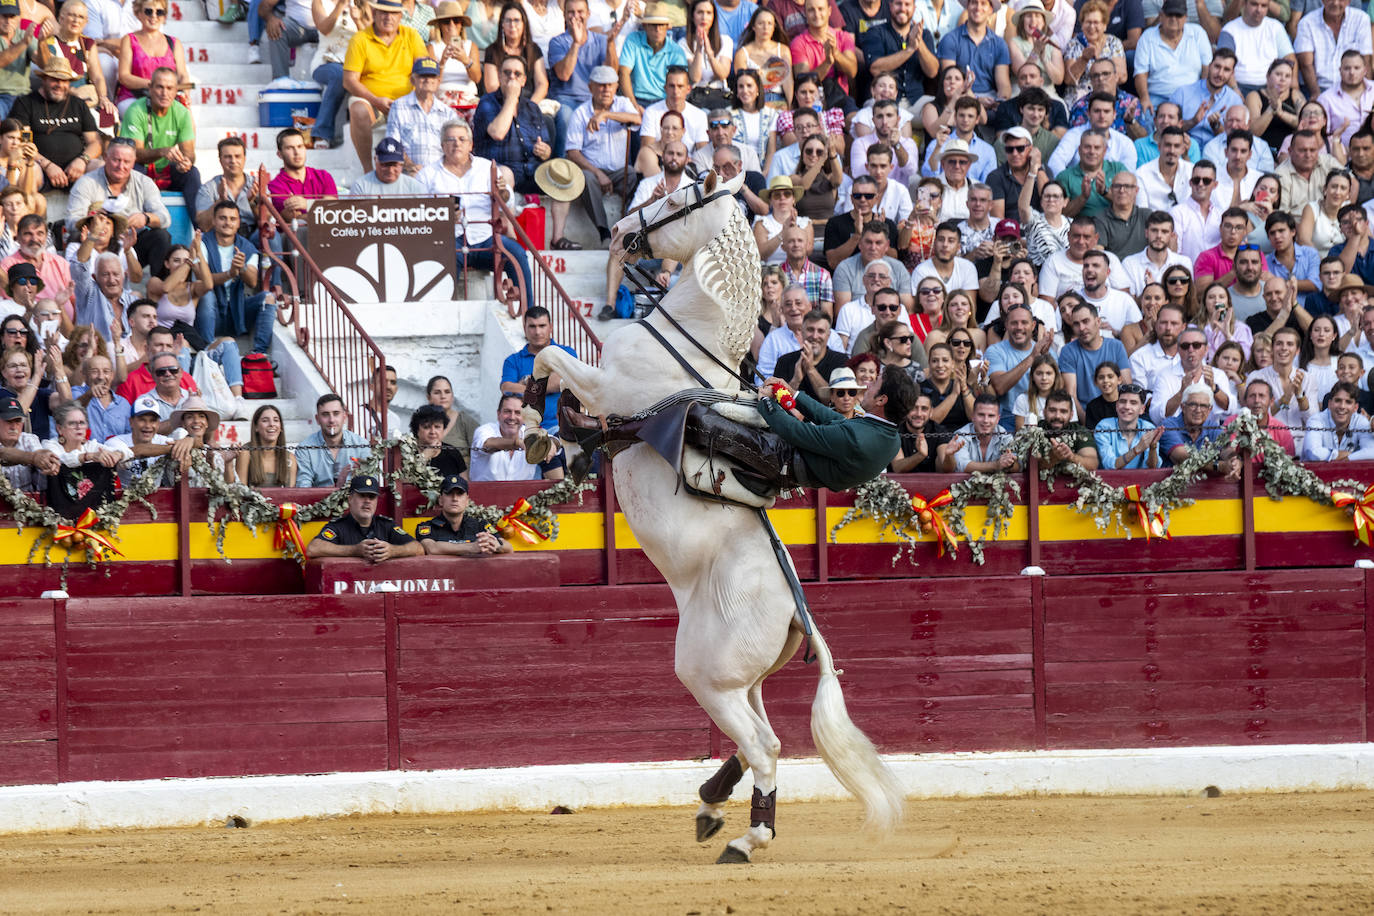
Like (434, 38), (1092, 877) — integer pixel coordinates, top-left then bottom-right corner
(13, 0), (1374, 527)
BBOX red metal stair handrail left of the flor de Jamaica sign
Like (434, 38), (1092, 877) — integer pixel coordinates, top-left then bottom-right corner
(260, 184), (389, 439)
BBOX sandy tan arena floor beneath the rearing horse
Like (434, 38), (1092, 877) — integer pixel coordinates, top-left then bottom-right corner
(0, 792), (1374, 916)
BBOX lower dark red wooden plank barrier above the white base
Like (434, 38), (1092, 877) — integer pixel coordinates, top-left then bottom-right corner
(0, 570), (1374, 784)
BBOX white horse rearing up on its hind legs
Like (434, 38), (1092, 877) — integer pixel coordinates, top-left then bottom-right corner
(525, 172), (903, 862)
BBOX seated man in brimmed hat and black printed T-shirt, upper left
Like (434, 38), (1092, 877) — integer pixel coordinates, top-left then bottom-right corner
(10, 58), (100, 188)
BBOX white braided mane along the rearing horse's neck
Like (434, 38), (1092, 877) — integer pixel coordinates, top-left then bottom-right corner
(695, 199), (763, 365)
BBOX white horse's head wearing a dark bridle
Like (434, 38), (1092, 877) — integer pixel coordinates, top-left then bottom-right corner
(610, 172), (745, 262)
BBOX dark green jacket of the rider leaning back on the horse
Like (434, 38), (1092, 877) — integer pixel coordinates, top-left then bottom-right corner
(758, 393), (901, 490)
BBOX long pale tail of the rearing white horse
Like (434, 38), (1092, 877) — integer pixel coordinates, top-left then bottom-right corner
(811, 623), (905, 831)
